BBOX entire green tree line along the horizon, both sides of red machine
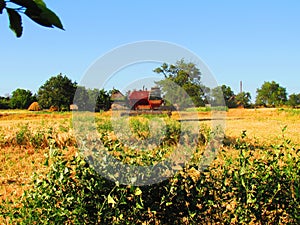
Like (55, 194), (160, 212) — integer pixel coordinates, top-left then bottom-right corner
(0, 59), (300, 112)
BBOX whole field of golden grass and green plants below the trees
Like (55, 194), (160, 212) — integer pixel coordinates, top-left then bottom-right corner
(0, 109), (300, 224)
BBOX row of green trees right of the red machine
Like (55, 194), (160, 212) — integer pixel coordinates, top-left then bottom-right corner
(154, 60), (300, 108)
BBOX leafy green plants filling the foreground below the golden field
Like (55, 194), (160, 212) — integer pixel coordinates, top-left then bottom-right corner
(0, 117), (300, 224)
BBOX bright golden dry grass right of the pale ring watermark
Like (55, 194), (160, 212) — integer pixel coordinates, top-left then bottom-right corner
(226, 109), (300, 144)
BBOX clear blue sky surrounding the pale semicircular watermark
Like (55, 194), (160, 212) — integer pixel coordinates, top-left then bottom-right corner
(0, 0), (300, 101)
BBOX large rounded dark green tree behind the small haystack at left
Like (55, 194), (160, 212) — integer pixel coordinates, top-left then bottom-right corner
(38, 74), (77, 110)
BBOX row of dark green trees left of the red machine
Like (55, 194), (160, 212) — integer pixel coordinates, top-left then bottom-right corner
(0, 74), (112, 111)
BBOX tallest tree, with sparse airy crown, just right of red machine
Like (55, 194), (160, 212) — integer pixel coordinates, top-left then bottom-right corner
(153, 59), (207, 108)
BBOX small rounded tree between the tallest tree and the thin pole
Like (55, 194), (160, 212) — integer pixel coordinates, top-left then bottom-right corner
(211, 84), (236, 108)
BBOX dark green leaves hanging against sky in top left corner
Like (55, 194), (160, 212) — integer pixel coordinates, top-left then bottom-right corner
(0, 0), (64, 37)
